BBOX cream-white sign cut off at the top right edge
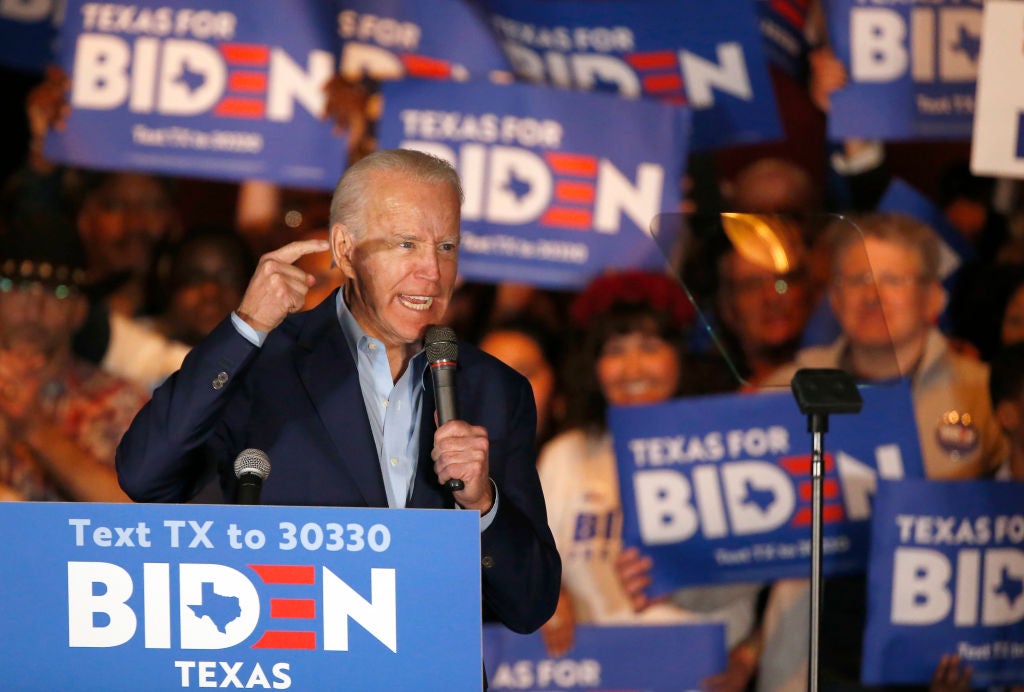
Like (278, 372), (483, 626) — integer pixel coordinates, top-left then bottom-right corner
(971, 0), (1024, 178)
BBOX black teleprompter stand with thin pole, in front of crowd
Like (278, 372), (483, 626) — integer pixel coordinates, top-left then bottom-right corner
(791, 367), (863, 692)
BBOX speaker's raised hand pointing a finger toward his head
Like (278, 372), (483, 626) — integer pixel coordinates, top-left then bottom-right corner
(236, 239), (331, 332)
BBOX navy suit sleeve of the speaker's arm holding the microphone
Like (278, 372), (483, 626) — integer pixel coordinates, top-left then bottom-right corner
(480, 372), (561, 634)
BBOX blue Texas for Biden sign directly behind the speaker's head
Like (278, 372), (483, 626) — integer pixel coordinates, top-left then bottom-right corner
(378, 80), (689, 289)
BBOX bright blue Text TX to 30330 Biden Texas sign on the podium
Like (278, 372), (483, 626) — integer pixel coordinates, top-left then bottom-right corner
(0, 503), (481, 690)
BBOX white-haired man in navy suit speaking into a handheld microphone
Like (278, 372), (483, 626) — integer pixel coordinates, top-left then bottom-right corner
(117, 149), (561, 633)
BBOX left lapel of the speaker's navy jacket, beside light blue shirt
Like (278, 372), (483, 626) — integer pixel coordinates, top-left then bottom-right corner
(298, 293), (391, 507)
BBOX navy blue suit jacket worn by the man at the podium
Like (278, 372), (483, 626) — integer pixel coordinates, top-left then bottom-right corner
(117, 295), (561, 632)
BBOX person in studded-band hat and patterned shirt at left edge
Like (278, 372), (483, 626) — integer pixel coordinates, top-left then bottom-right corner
(0, 226), (147, 502)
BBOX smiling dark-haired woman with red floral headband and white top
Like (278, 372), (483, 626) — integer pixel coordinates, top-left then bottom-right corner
(538, 271), (757, 687)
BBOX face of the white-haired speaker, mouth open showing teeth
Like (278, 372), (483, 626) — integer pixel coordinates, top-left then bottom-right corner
(333, 172), (459, 346)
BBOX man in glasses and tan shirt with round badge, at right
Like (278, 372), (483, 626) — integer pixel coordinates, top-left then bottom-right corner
(759, 213), (1006, 690)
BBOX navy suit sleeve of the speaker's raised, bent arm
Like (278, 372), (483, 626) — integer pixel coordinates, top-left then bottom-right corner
(116, 319), (258, 503)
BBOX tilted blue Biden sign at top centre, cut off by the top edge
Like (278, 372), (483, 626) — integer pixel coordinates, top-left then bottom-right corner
(482, 0), (781, 149)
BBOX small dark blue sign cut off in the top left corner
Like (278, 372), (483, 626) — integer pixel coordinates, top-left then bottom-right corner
(0, 0), (63, 73)
